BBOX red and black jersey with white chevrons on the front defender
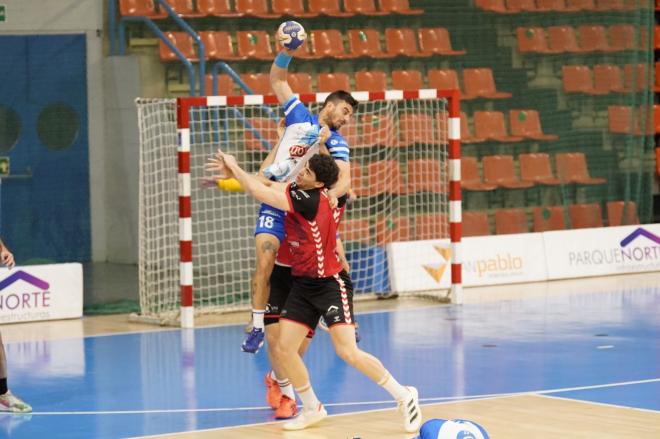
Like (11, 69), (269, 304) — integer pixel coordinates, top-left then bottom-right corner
(284, 183), (342, 277)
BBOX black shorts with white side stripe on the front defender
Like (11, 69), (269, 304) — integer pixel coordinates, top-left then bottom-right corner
(280, 271), (355, 330)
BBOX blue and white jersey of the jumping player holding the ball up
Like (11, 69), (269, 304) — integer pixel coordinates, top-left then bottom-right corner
(264, 96), (349, 182)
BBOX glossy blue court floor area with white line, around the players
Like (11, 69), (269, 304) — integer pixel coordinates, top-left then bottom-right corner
(0, 280), (660, 438)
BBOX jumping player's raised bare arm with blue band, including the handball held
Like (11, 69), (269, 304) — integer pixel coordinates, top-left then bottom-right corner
(270, 21), (307, 104)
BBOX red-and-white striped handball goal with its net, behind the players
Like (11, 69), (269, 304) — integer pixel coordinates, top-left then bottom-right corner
(135, 89), (462, 328)
